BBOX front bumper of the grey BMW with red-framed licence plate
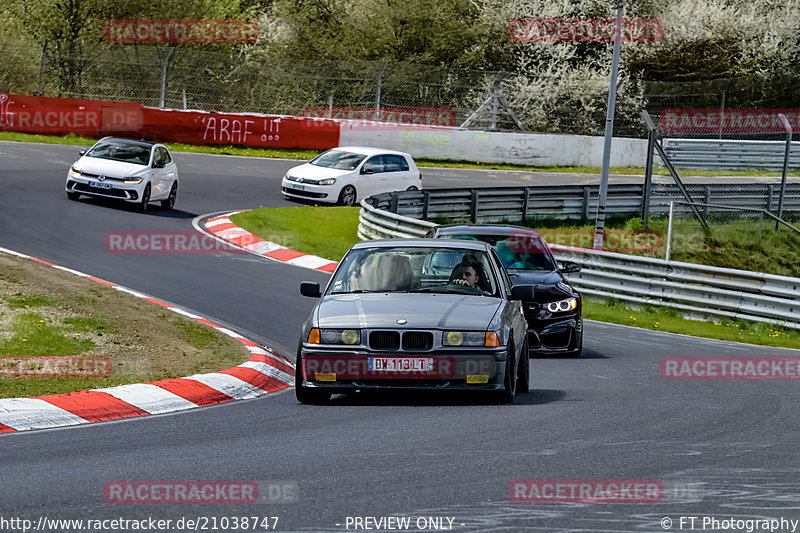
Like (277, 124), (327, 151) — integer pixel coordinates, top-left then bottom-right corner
(296, 344), (507, 393)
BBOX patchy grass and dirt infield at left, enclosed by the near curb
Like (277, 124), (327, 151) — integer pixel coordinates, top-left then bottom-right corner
(0, 254), (250, 398)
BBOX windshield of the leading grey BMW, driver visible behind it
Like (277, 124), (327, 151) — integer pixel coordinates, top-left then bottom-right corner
(330, 247), (498, 296)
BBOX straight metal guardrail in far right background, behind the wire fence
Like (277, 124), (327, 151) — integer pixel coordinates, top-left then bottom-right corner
(663, 138), (800, 172)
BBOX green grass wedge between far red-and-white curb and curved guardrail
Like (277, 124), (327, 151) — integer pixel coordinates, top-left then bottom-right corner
(231, 206), (360, 261)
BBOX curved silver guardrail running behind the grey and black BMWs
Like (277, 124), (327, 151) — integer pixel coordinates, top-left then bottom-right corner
(358, 195), (800, 329)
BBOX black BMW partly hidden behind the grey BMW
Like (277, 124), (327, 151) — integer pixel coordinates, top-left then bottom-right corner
(429, 225), (583, 357)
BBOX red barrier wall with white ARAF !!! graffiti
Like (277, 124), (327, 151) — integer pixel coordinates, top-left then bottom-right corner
(0, 94), (339, 150)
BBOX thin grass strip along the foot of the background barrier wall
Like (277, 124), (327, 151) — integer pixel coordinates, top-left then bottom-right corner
(0, 132), (800, 176)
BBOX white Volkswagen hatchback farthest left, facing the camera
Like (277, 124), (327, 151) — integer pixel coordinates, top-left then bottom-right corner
(66, 137), (178, 211)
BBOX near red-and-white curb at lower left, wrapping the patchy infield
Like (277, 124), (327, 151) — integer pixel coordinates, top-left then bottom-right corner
(0, 248), (294, 433)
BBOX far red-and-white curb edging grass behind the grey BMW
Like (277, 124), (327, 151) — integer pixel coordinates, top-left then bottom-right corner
(204, 211), (339, 272)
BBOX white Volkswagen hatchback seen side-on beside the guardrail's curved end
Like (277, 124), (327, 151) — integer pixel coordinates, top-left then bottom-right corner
(281, 146), (422, 205)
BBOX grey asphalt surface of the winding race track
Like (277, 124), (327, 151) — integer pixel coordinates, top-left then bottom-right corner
(0, 143), (800, 532)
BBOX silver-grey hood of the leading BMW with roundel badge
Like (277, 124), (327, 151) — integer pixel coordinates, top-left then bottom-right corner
(317, 293), (500, 330)
